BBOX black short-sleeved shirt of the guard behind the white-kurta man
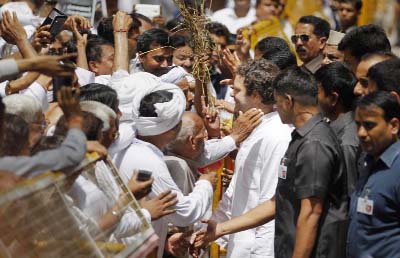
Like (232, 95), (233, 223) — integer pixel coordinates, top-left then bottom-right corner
(275, 115), (348, 258)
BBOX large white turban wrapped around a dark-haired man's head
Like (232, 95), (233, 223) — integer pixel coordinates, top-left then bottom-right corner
(110, 72), (186, 136)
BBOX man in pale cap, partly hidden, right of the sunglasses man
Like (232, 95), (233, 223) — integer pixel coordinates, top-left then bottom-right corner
(322, 30), (346, 65)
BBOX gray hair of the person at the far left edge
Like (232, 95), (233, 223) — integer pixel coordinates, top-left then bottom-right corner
(3, 94), (42, 124)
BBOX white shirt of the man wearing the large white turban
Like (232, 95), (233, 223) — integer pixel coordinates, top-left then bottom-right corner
(113, 139), (213, 258)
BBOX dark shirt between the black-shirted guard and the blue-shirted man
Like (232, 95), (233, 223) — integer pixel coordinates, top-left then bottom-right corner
(331, 111), (361, 196)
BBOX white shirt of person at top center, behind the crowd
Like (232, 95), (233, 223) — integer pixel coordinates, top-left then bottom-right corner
(211, 7), (257, 34)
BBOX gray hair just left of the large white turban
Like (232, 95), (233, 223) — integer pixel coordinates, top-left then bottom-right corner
(80, 100), (117, 132)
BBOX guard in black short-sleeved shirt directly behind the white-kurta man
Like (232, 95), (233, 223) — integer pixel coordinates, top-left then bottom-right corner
(274, 68), (348, 258)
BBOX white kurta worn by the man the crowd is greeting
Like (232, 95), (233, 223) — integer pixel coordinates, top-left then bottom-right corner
(213, 112), (292, 258)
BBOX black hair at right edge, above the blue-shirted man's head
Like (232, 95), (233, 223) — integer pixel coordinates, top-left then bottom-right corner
(367, 58), (400, 95)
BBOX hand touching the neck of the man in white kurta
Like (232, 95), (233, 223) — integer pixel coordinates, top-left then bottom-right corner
(230, 108), (264, 145)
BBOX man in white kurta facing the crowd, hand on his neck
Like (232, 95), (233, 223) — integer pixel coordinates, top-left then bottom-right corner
(211, 60), (291, 258)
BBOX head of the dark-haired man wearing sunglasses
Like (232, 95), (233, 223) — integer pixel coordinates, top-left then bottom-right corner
(291, 16), (330, 73)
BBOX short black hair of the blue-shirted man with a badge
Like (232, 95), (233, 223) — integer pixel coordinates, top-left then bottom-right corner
(357, 91), (400, 122)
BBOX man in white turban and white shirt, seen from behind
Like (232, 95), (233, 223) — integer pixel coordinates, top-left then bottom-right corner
(112, 73), (216, 258)
